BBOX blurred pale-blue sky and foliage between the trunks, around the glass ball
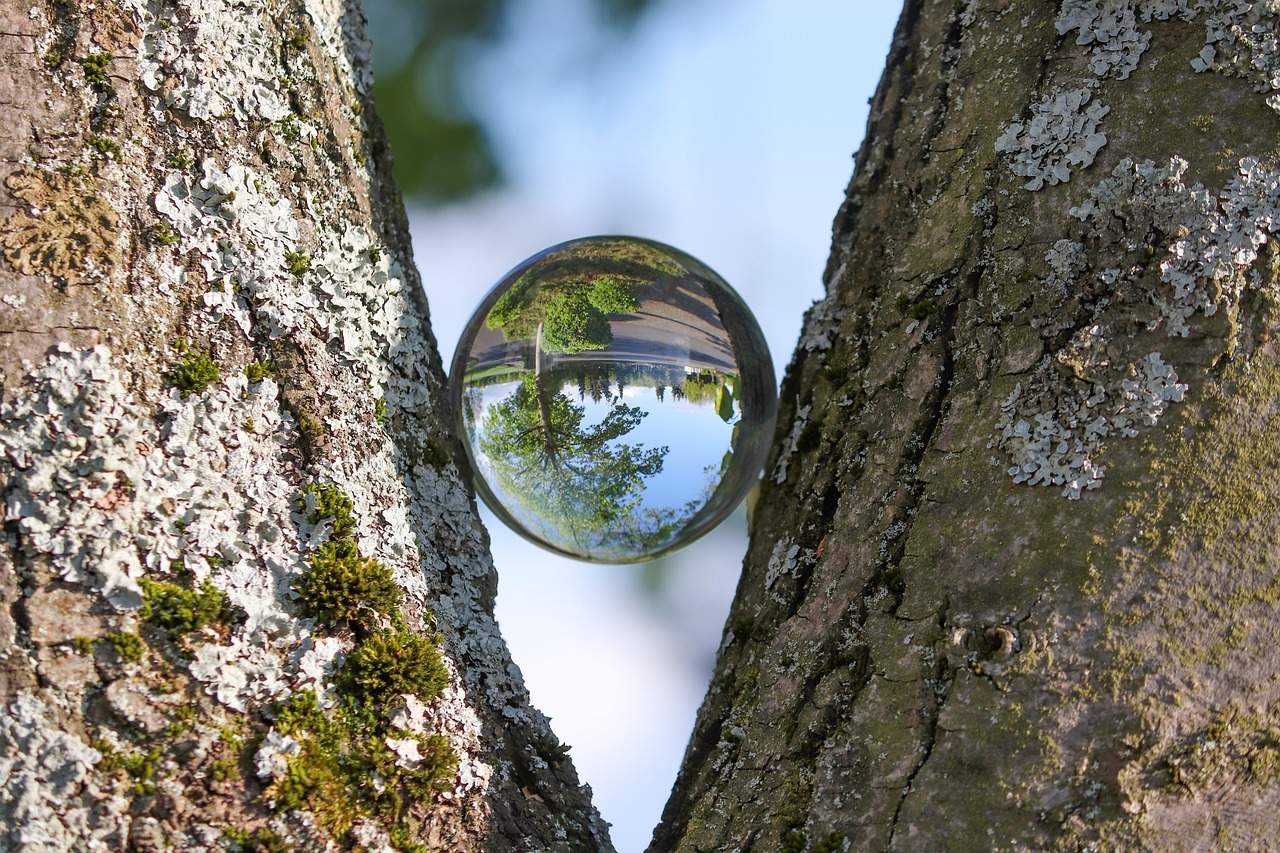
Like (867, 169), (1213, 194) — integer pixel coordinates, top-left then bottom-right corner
(365, 0), (899, 853)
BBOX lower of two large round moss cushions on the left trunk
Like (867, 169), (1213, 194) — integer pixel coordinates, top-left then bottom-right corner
(342, 626), (449, 707)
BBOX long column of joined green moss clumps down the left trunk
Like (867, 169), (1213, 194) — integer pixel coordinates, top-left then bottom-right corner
(266, 483), (457, 850)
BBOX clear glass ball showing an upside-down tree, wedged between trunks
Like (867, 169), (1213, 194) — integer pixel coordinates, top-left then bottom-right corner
(449, 237), (777, 562)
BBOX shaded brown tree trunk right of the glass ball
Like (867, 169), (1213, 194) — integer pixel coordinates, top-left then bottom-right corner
(652, 0), (1280, 853)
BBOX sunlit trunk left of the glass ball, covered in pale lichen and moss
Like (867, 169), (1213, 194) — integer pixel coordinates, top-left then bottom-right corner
(0, 0), (609, 850)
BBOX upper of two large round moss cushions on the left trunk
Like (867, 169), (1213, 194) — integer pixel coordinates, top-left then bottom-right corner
(293, 539), (401, 628)
